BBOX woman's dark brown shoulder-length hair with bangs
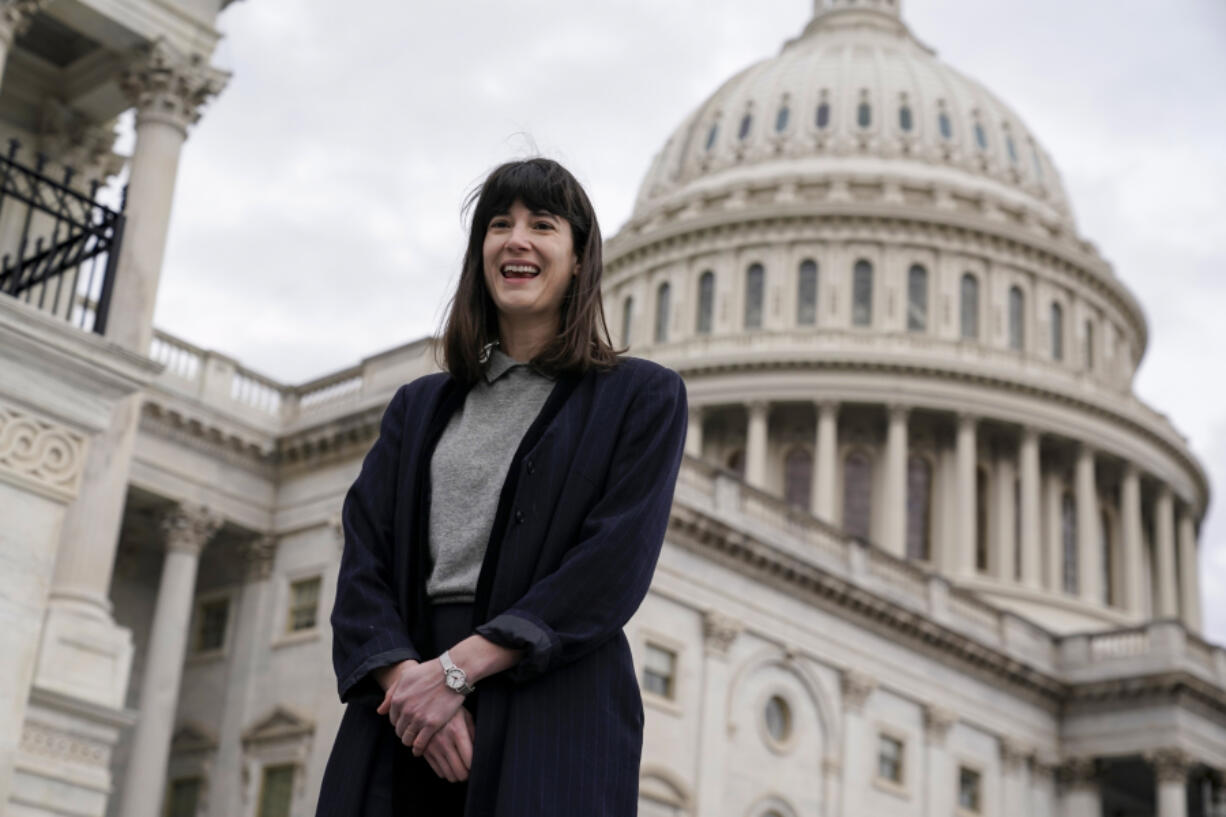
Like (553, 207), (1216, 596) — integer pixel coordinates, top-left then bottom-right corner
(440, 157), (626, 385)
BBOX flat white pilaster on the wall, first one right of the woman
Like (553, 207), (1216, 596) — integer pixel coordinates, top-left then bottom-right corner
(694, 610), (743, 815)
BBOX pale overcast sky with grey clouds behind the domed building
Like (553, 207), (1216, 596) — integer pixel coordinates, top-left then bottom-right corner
(136, 0), (1226, 643)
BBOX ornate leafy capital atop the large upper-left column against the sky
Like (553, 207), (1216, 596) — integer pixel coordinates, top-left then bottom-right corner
(119, 38), (230, 134)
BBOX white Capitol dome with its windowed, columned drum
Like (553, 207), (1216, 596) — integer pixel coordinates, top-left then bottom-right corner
(604, 0), (1209, 632)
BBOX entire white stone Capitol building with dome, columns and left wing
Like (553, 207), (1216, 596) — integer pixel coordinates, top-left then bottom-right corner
(0, 0), (1226, 817)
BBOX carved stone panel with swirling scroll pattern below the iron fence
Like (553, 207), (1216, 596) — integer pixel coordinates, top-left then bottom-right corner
(0, 402), (87, 501)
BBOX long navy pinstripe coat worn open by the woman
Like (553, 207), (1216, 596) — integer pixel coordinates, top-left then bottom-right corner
(316, 357), (688, 817)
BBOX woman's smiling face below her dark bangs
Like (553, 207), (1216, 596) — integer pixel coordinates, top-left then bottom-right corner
(482, 199), (579, 328)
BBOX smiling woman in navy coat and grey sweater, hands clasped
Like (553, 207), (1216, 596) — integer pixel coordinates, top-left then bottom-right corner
(318, 158), (687, 817)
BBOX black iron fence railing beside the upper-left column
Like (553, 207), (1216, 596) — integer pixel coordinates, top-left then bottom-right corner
(0, 140), (126, 335)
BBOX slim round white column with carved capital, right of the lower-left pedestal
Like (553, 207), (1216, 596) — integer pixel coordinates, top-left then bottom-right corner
(120, 507), (222, 817)
